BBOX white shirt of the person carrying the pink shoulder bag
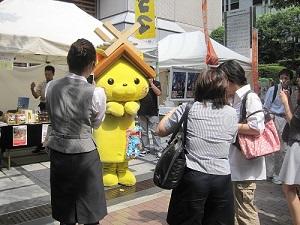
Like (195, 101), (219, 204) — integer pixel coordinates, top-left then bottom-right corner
(229, 85), (266, 181)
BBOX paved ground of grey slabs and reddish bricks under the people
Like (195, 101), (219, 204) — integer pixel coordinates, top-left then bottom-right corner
(0, 149), (292, 225)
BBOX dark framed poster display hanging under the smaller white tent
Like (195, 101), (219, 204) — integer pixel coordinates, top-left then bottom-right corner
(169, 68), (199, 101)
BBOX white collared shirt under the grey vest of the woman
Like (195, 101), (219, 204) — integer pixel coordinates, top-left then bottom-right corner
(45, 73), (106, 128)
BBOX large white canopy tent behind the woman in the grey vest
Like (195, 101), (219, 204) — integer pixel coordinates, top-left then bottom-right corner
(0, 0), (112, 111)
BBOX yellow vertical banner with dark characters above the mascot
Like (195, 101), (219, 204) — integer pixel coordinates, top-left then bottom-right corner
(135, 0), (156, 39)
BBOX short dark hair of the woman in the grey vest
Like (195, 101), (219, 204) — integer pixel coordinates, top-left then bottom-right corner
(67, 38), (96, 75)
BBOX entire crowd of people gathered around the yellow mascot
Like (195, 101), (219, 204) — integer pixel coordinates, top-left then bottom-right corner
(31, 39), (300, 225)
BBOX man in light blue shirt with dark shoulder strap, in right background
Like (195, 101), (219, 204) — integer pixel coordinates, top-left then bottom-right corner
(264, 69), (293, 184)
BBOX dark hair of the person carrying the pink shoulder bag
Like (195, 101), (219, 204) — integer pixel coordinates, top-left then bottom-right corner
(218, 60), (247, 86)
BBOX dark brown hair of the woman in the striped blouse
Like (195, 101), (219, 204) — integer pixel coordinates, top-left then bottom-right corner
(195, 69), (228, 109)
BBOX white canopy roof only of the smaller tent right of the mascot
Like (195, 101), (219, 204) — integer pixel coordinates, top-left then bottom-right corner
(158, 31), (251, 70)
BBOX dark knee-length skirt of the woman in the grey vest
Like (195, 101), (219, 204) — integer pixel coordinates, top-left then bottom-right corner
(49, 149), (107, 224)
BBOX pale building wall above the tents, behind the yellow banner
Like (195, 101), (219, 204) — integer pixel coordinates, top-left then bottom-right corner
(55, 0), (222, 40)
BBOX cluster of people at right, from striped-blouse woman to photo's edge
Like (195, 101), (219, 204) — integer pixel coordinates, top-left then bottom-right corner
(157, 60), (300, 225)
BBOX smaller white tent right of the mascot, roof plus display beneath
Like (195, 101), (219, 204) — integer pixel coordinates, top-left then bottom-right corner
(158, 31), (251, 105)
